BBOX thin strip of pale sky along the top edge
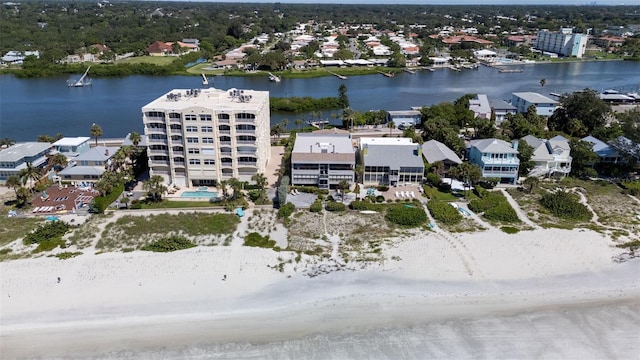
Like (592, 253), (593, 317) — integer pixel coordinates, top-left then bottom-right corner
(154, 0), (640, 6)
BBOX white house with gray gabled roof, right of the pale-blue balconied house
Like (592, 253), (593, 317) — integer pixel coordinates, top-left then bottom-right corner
(520, 135), (571, 176)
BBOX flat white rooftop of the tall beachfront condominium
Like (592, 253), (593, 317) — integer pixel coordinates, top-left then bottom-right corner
(142, 88), (269, 112)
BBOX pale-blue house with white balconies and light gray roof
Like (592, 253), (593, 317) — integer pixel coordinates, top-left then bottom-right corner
(467, 138), (520, 184)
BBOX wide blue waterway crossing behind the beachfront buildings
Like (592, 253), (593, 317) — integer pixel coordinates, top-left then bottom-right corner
(0, 61), (640, 141)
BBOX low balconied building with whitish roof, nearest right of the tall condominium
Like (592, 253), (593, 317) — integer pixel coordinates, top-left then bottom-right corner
(291, 131), (356, 189)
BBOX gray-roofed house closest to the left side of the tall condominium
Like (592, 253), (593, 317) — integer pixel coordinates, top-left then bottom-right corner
(58, 146), (120, 182)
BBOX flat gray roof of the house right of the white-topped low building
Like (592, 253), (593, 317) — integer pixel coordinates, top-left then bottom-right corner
(364, 144), (424, 169)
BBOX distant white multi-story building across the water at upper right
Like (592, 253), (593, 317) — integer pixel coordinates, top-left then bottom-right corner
(535, 28), (589, 58)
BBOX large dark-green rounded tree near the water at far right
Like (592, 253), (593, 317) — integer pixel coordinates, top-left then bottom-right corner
(548, 89), (611, 136)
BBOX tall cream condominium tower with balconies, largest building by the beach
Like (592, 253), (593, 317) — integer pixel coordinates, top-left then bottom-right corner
(142, 88), (271, 186)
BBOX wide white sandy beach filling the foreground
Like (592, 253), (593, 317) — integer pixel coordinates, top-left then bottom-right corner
(0, 215), (640, 359)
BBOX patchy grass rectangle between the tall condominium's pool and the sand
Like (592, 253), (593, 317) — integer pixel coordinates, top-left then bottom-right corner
(96, 213), (240, 250)
